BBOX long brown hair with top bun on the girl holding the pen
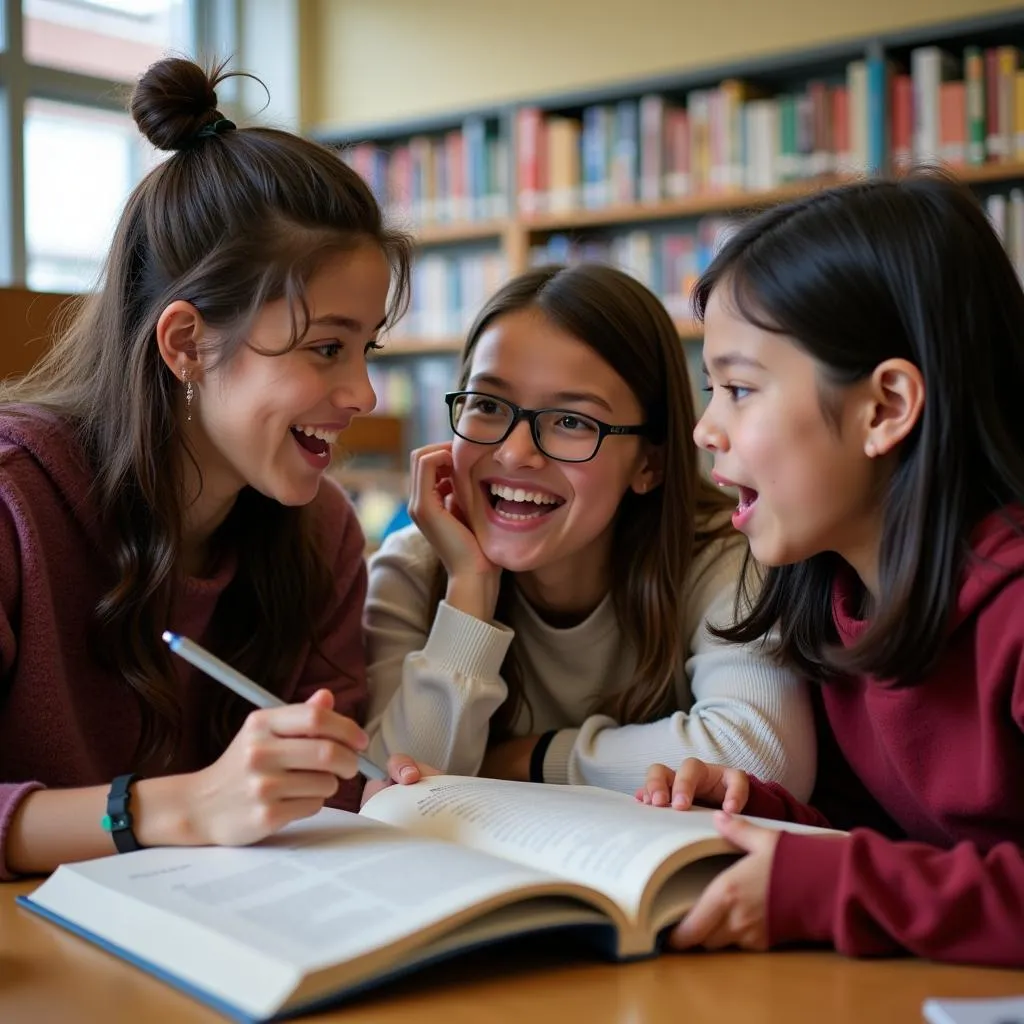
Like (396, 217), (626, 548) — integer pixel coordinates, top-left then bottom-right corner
(2, 59), (410, 765)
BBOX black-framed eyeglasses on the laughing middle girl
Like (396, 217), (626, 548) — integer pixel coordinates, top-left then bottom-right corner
(444, 391), (648, 462)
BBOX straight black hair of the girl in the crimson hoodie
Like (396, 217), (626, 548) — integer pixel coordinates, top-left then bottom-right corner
(694, 172), (1024, 684)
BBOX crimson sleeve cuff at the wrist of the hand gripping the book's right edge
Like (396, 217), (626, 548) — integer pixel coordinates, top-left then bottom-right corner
(768, 833), (850, 946)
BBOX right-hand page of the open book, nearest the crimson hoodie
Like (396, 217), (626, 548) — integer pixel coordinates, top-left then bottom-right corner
(360, 775), (730, 924)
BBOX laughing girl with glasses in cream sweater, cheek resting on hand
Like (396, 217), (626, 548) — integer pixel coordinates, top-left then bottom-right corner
(366, 265), (815, 795)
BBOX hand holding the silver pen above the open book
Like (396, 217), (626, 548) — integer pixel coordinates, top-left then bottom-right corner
(179, 690), (369, 846)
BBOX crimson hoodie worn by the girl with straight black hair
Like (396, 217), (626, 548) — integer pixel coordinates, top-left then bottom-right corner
(744, 515), (1024, 968)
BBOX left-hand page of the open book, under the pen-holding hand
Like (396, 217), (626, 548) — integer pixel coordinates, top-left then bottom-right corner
(32, 809), (598, 1007)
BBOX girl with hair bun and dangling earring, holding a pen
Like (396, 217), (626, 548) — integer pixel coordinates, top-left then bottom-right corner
(0, 51), (419, 878)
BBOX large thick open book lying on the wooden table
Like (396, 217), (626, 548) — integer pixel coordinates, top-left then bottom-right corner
(23, 776), (839, 1020)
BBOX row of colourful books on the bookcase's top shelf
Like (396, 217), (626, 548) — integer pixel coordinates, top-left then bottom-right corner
(346, 37), (1024, 235)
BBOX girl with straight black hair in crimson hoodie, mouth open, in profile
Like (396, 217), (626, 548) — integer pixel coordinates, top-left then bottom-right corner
(640, 174), (1024, 968)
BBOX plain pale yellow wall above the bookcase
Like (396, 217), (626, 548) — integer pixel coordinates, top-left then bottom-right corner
(301, 0), (1020, 129)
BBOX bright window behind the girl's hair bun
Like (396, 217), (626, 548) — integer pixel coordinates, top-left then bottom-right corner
(0, 0), (249, 292)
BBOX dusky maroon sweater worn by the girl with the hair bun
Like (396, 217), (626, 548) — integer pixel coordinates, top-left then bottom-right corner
(0, 413), (367, 880)
